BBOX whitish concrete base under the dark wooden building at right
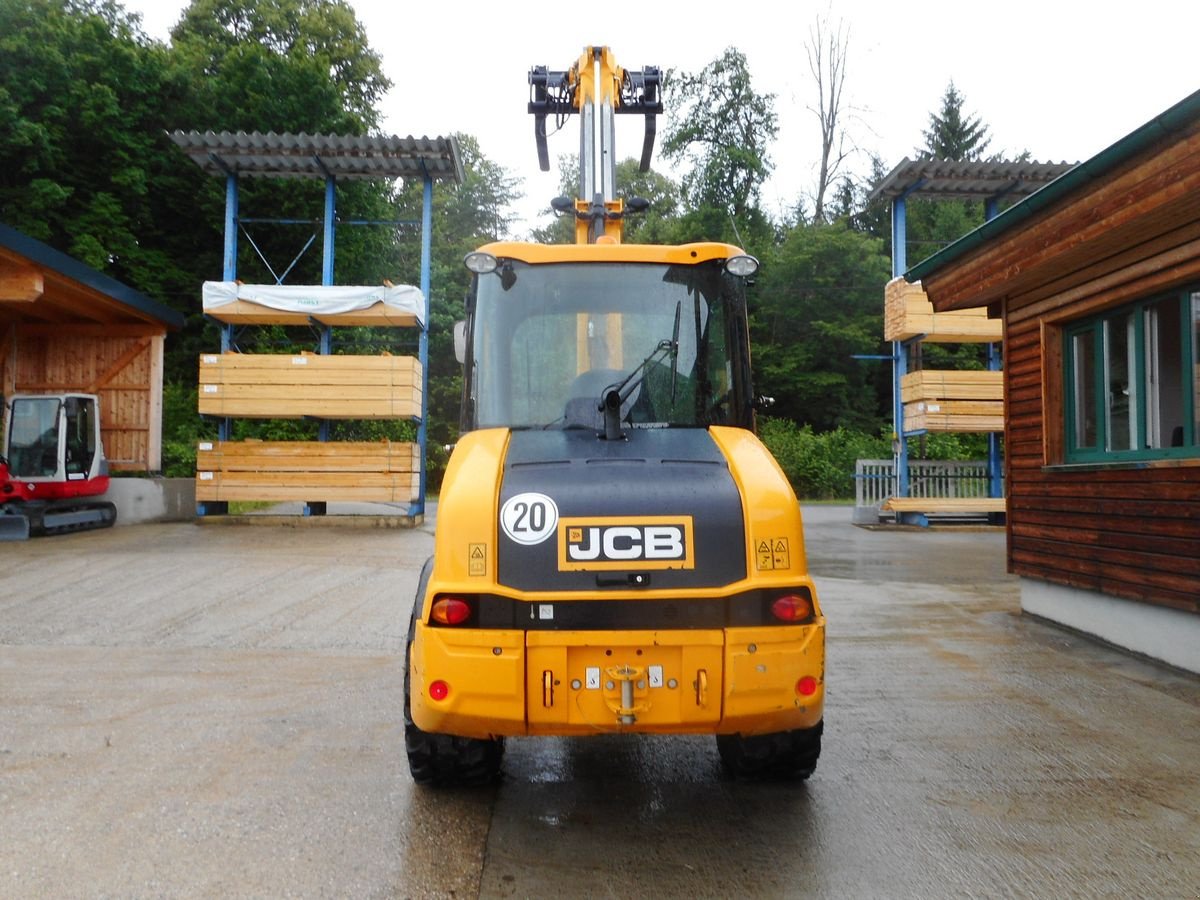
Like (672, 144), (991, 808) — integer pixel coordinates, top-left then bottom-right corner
(1021, 578), (1200, 673)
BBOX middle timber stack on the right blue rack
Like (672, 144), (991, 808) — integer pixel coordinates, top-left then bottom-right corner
(900, 370), (1004, 432)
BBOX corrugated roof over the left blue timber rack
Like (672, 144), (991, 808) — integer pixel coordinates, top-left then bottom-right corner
(169, 131), (463, 185)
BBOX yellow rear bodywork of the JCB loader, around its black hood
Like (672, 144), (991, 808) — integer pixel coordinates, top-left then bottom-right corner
(410, 427), (824, 738)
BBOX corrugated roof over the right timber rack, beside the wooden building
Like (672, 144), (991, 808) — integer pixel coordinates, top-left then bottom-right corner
(869, 157), (1075, 200)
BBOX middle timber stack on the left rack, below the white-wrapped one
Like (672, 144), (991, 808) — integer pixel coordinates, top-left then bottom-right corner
(199, 353), (421, 419)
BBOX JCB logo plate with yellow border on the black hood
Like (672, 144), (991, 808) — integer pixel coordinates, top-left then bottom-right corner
(558, 516), (695, 571)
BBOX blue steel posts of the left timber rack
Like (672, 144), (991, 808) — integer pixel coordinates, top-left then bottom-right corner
(197, 170), (433, 517)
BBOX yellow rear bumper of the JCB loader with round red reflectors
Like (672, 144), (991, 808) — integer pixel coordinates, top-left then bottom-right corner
(409, 618), (824, 738)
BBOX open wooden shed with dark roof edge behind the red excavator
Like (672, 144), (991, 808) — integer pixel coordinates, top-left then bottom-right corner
(0, 224), (184, 472)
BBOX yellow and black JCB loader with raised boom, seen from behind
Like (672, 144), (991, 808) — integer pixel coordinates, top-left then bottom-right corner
(404, 47), (824, 785)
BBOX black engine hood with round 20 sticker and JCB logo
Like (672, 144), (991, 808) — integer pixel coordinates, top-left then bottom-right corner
(498, 428), (746, 593)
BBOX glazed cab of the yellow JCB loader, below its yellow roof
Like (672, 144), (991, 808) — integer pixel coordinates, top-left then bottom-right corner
(462, 253), (752, 437)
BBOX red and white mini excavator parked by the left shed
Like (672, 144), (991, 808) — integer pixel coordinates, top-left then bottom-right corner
(0, 394), (116, 541)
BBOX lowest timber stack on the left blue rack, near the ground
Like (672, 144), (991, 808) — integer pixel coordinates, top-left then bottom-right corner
(196, 440), (421, 503)
